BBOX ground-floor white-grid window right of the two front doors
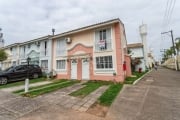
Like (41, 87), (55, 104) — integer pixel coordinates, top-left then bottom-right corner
(96, 56), (113, 70)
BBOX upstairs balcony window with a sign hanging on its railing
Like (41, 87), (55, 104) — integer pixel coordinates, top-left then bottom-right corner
(95, 28), (112, 51)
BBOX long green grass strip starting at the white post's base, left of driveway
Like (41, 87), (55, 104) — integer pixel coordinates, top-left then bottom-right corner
(22, 81), (79, 97)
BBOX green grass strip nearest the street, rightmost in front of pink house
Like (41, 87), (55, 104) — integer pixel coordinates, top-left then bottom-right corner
(98, 84), (123, 106)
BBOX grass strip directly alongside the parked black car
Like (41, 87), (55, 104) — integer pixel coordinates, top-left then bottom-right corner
(0, 77), (46, 89)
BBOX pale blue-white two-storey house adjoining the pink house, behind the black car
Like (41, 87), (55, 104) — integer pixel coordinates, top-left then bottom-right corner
(19, 36), (52, 73)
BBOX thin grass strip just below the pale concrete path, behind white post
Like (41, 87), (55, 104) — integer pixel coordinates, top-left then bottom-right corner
(13, 80), (69, 94)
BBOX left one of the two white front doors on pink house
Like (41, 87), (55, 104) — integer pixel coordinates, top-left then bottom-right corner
(71, 60), (77, 79)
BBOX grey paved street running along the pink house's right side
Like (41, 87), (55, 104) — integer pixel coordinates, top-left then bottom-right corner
(106, 68), (180, 120)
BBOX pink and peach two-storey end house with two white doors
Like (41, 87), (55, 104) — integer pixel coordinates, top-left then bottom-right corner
(52, 19), (131, 82)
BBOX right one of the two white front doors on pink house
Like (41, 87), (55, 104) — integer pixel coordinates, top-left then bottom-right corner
(82, 59), (89, 80)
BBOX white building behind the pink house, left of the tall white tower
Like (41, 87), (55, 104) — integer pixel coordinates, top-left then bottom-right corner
(127, 43), (146, 71)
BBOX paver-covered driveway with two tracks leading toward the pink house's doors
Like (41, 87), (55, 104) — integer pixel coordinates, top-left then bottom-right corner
(0, 83), (107, 120)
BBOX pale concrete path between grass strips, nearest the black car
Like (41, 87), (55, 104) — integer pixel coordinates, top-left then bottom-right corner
(0, 81), (52, 92)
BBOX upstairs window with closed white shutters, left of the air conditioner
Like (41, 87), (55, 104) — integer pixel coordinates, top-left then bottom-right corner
(56, 38), (66, 56)
